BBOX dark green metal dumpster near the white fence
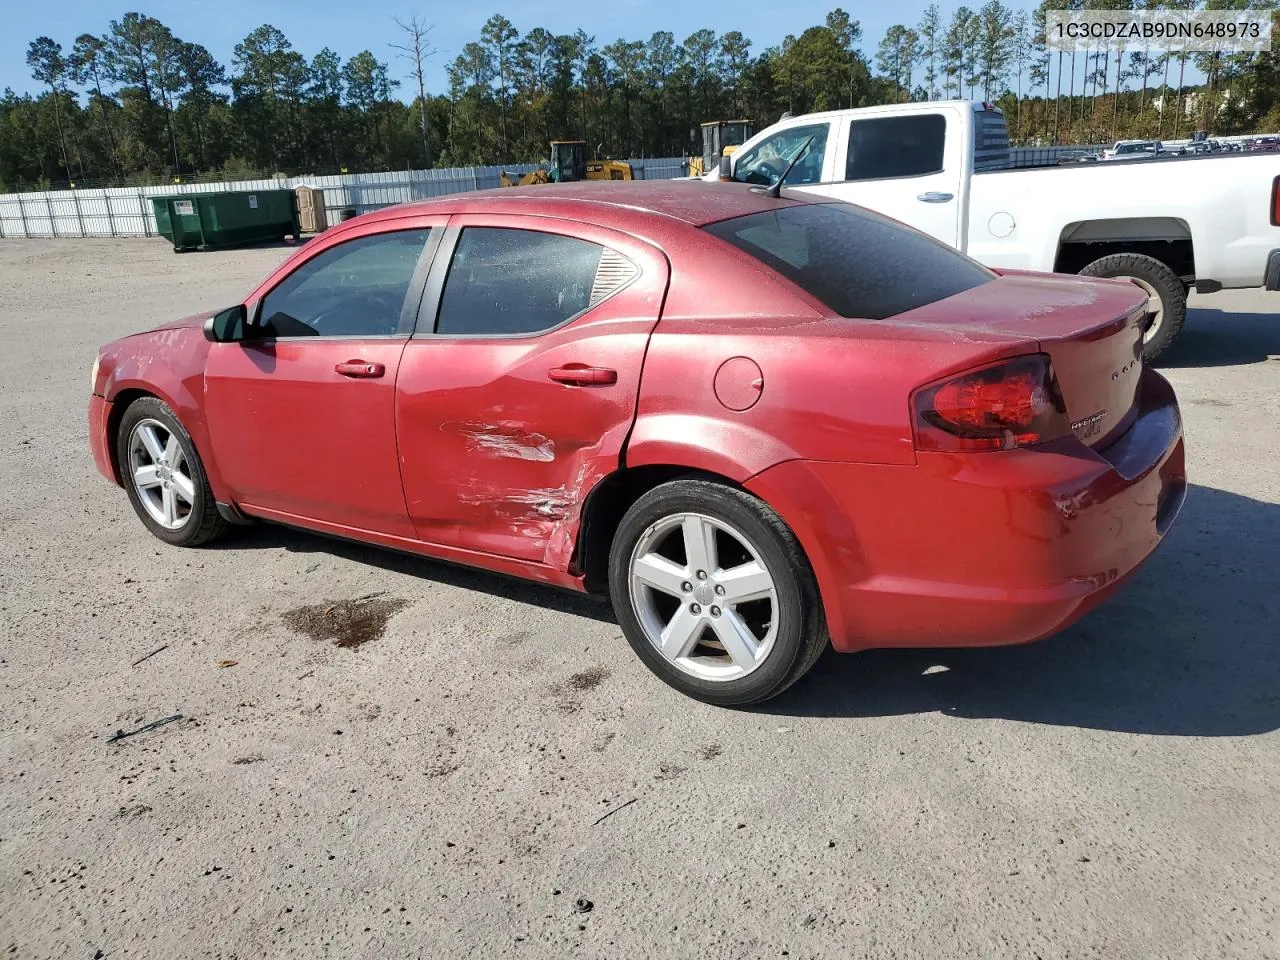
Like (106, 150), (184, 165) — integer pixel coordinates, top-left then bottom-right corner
(151, 189), (300, 251)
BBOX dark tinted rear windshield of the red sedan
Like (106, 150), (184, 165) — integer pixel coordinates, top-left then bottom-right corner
(704, 204), (995, 320)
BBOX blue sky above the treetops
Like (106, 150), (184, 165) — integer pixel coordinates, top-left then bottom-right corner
(0, 0), (1059, 93)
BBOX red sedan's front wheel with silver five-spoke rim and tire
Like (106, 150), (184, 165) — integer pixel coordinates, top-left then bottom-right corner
(116, 397), (228, 547)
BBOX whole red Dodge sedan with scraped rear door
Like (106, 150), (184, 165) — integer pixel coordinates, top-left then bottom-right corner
(90, 182), (1187, 704)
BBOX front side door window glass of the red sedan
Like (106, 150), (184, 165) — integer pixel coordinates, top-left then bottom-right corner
(259, 229), (431, 339)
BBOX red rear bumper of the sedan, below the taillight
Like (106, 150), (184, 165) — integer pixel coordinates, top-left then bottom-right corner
(746, 370), (1187, 652)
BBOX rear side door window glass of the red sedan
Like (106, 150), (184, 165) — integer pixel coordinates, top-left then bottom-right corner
(435, 227), (604, 337)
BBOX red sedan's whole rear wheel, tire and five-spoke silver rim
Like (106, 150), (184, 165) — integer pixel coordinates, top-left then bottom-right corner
(609, 480), (827, 705)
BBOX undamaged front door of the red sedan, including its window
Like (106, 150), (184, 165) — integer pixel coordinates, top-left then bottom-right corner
(205, 216), (447, 539)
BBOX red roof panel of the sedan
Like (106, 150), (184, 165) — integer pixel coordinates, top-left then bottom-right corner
(360, 180), (820, 227)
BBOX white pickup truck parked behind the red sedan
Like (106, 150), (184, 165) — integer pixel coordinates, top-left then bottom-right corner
(707, 100), (1280, 360)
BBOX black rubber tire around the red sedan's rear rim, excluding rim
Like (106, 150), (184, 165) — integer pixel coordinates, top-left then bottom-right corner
(609, 480), (829, 707)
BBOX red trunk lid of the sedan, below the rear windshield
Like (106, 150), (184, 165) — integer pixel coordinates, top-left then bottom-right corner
(892, 271), (1147, 447)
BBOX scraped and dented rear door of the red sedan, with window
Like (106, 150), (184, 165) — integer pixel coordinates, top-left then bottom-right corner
(396, 215), (668, 568)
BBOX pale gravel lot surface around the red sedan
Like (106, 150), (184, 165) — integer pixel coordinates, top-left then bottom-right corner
(0, 241), (1280, 960)
